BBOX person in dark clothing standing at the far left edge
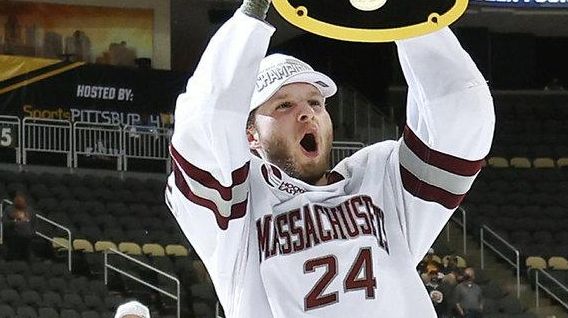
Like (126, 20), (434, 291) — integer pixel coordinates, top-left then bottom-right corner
(2, 193), (36, 260)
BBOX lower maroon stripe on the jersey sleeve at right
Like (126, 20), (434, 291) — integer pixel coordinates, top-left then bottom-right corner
(400, 165), (465, 209)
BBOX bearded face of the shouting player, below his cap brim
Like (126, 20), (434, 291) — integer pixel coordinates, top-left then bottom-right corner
(248, 83), (333, 184)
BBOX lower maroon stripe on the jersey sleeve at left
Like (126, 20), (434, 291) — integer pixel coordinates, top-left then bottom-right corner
(173, 164), (248, 230)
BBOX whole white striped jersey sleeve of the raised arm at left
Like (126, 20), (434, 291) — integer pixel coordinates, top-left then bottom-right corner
(166, 11), (274, 312)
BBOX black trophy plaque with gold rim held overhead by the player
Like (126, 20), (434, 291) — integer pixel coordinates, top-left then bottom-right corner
(272, 0), (468, 42)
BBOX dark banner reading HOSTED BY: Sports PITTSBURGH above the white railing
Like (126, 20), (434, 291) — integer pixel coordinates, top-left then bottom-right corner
(0, 55), (189, 127)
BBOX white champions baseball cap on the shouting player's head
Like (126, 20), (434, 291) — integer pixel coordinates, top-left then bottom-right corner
(250, 54), (337, 111)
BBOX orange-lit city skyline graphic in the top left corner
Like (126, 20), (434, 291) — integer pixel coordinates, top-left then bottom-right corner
(0, 1), (153, 66)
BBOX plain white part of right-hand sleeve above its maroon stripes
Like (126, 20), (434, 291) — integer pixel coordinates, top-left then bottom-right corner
(397, 28), (495, 161)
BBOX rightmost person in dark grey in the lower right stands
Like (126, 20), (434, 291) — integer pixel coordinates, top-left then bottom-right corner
(454, 267), (483, 318)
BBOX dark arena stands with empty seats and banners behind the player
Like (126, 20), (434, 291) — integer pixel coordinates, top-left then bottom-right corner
(0, 0), (568, 318)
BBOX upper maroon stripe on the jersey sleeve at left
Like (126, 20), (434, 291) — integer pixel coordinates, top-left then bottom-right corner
(170, 146), (250, 201)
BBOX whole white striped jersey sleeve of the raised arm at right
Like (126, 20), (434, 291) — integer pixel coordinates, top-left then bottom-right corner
(390, 28), (495, 263)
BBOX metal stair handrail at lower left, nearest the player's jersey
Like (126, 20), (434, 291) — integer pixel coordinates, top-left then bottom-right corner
(103, 248), (181, 318)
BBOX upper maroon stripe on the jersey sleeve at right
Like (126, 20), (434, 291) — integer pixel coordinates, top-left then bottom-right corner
(404, 126), (483, 177)
